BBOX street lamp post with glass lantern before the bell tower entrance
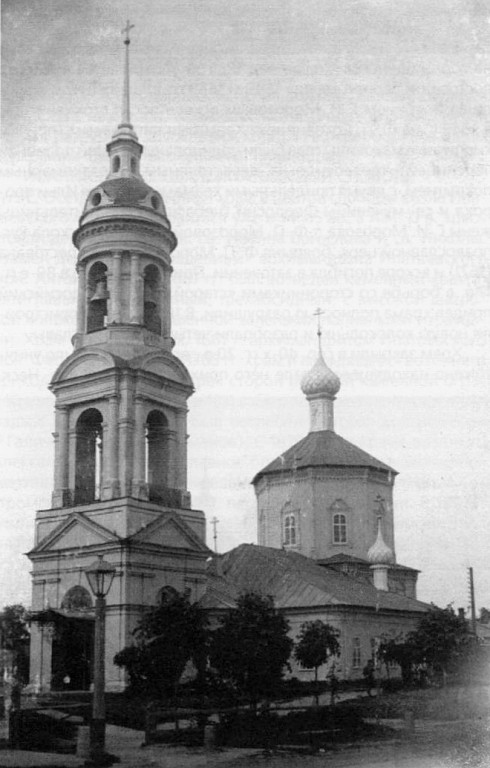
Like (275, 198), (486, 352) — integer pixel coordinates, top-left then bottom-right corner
(85, 555), (116, 765)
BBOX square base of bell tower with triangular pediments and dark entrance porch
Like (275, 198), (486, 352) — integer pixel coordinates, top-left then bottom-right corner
(28, 498), (211, 693)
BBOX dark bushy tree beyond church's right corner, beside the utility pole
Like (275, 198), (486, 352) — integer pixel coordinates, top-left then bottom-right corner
(407, 605), (472, 683)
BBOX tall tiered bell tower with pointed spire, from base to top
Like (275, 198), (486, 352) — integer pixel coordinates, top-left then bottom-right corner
(29, 23), (209, 689)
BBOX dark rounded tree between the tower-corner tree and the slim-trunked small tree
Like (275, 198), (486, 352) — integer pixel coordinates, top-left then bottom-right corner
(210, 592), (293, 707)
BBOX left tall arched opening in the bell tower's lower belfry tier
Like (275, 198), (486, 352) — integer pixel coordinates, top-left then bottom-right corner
(75, 408), (104, 504)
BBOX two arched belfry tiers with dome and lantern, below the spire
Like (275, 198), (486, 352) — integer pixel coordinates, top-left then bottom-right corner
(50, 109), (193, 508)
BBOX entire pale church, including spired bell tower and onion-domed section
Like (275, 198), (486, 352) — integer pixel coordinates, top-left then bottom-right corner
(28, 33), (426, 691)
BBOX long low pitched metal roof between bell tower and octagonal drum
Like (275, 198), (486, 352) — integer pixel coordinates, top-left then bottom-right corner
(206, 544), (427, 613)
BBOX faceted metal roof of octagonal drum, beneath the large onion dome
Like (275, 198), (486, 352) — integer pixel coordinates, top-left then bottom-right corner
(252, 429), (398, 483)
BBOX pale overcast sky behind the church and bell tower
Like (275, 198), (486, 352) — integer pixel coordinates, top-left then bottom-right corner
(0, 0), (490, 608)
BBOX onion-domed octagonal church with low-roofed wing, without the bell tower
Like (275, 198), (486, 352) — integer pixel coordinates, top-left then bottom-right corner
(201, 327), (427, 679)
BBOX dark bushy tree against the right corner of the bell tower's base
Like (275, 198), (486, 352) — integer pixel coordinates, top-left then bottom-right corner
(114, 593), (207, 698)
